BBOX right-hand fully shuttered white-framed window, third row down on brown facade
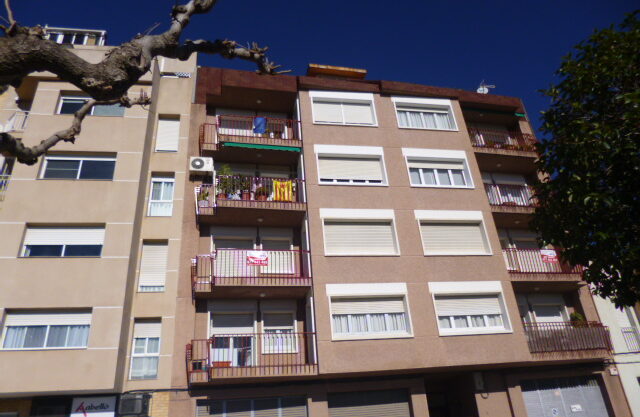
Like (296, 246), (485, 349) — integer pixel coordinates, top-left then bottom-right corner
(415, 210), (491, 255)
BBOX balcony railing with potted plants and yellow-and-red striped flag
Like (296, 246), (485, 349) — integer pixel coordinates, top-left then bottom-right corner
(196, 175), (304, 214)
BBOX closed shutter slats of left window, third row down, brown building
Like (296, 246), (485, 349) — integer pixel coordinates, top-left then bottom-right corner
(324, 220), (397, 255)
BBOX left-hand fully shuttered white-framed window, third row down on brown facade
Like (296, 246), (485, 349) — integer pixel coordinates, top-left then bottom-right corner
(320, 209), (399, 256)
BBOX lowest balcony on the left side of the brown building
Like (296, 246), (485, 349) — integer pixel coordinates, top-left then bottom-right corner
(186, 331), (318, 384)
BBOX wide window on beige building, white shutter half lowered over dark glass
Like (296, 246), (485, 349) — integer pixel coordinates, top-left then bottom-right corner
(22, 226), (104, 257)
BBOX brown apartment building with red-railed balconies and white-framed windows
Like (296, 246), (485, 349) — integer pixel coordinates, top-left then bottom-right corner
(169, 65), (631, 417)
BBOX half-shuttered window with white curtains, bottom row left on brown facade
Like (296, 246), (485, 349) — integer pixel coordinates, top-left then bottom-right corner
(331, 297), (409, 336)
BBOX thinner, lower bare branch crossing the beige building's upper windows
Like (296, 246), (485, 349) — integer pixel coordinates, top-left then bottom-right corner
(0, 94), (151, 165)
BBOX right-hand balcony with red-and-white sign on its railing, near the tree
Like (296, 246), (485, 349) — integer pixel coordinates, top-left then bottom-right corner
(502, 249), (583, 281)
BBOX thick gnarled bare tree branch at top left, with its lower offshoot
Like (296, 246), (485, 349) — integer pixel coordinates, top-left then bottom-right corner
(0, 0), (288, 164)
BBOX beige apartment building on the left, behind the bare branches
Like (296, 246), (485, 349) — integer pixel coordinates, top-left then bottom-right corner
(0, 27), (196, 417)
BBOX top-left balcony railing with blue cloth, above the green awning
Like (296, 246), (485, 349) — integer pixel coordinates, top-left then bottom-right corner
(200, 115), (301, 151)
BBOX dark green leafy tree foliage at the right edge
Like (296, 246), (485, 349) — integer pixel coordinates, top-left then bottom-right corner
(532, 10), (640, 306)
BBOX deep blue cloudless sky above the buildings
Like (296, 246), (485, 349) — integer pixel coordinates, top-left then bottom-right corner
(13, 0), (638, 131)
